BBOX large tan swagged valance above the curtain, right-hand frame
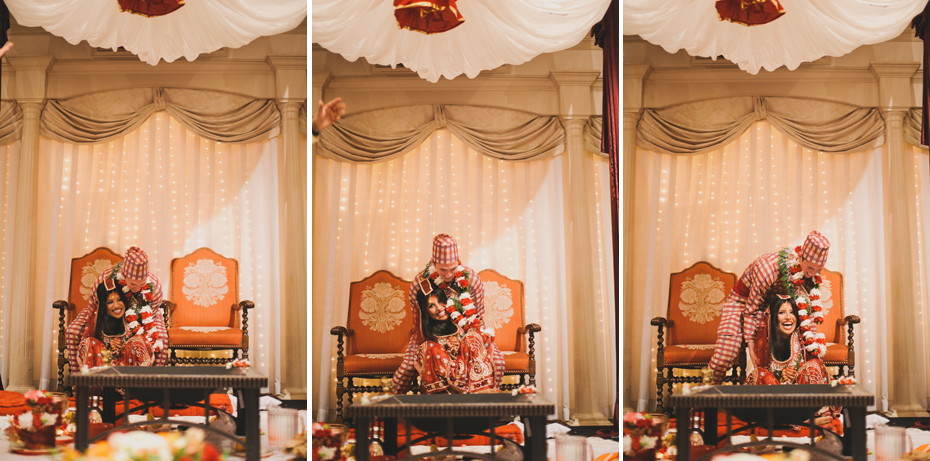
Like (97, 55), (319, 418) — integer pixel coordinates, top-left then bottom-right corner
(637, 96), (884, 154)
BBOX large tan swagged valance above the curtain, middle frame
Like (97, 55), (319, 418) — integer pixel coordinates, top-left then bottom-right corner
(314, 104), (565, 162)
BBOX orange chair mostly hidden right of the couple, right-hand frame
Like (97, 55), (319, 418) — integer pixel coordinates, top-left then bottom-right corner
(817, 269), (859, 377)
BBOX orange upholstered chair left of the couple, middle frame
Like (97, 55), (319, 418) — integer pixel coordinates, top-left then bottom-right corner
(330, 270), (413, 420)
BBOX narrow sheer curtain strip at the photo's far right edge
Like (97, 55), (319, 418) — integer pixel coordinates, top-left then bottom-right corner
(905, 144), (930, 408)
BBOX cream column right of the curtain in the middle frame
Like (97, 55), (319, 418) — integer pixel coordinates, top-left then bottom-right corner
(549, 72), (616, 425)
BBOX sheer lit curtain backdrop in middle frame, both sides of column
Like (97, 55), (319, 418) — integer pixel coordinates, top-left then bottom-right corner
(312, 129), (600, 420)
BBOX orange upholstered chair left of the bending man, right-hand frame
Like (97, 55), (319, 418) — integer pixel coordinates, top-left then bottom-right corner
(651, 261), (746, 411)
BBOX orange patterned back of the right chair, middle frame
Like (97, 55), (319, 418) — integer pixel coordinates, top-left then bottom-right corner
(478, 269), (526, 352)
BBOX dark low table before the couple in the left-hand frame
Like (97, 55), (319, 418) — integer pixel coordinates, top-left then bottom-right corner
(70, 366), (268, 461)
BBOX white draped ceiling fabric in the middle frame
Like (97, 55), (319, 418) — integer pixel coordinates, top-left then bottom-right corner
(312, 0), (610, 83)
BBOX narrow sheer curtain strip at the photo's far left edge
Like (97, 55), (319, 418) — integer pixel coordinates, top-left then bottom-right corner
(0, 141), (22, 389)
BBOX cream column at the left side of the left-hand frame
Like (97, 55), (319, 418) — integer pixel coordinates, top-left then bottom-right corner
(6, 56), (54, 392)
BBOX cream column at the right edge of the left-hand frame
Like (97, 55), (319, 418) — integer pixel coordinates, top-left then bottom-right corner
(268, 56), (308, 400)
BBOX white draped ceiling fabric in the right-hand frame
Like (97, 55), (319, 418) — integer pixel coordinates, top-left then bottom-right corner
(623, 0), (927, 74)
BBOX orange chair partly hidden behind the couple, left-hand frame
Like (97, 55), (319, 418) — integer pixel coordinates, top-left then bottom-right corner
(52, 247), (123, 392)
